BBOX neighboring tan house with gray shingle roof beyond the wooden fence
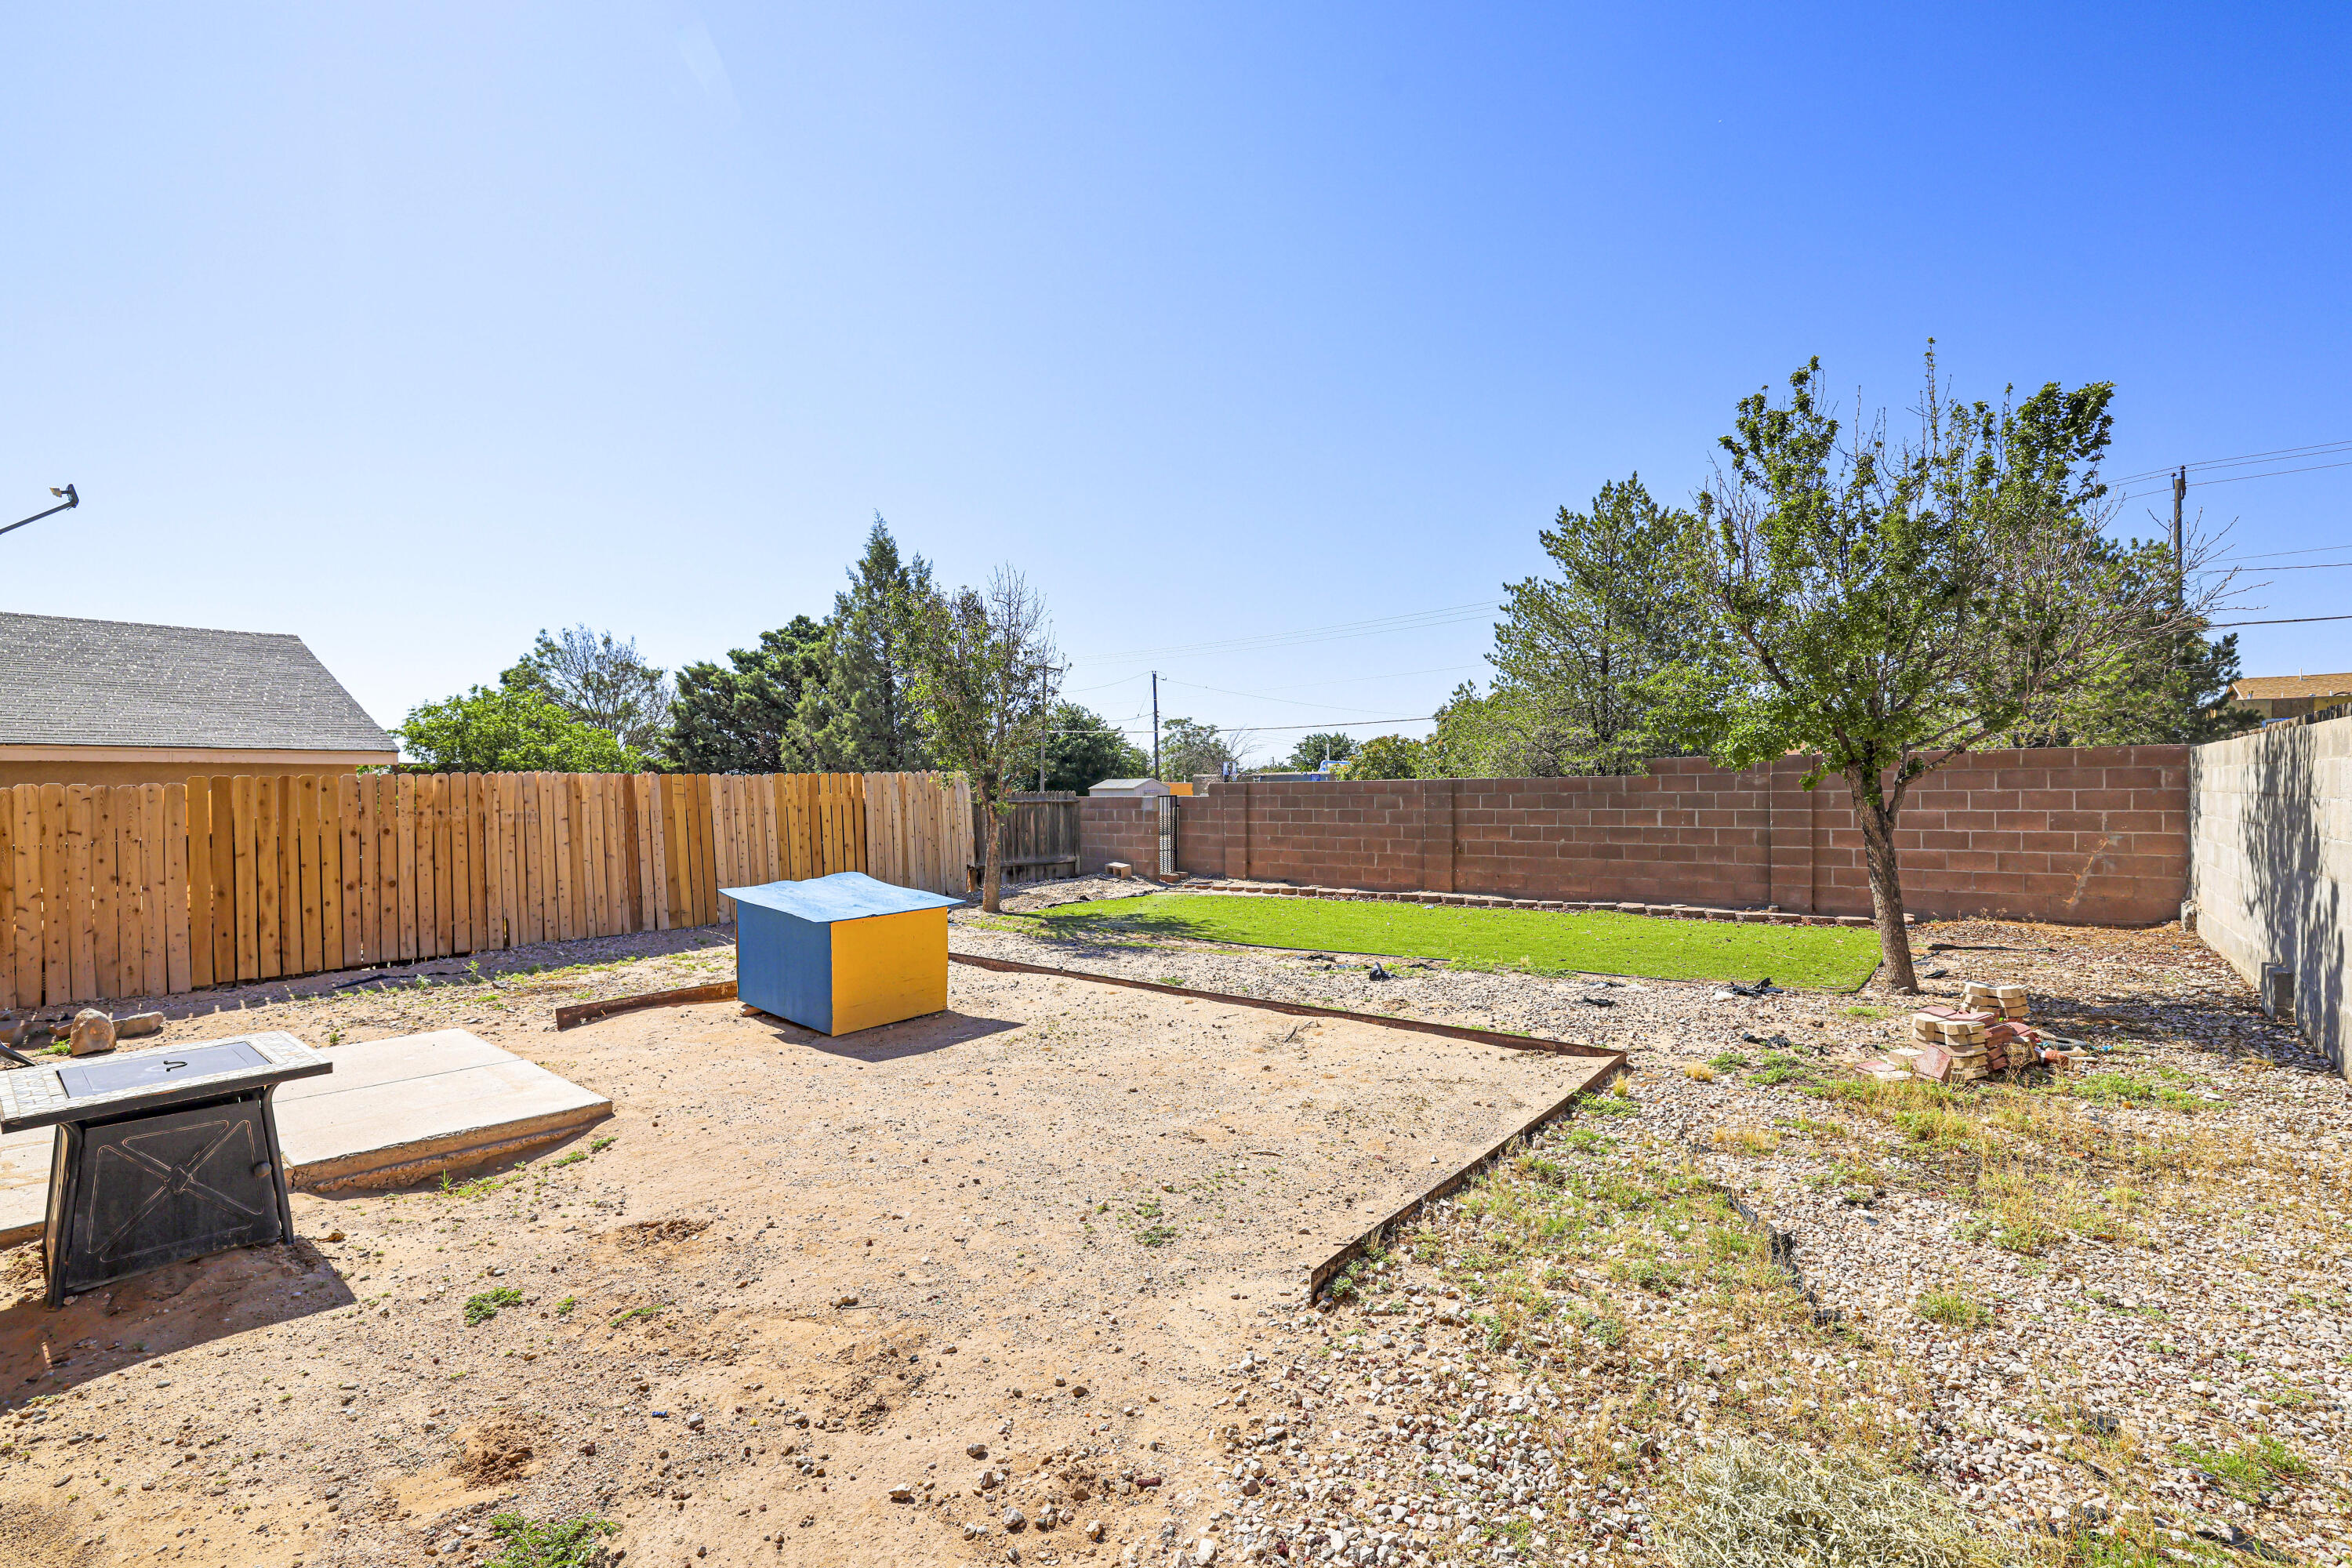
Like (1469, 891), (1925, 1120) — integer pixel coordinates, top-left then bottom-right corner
(0, 614), (400, 785)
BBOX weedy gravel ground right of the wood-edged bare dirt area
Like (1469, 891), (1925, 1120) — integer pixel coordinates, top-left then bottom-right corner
(957, 893), (2352, 1563)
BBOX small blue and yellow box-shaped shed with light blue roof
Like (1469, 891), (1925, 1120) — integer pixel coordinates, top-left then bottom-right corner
(722, 872), (960, 1034)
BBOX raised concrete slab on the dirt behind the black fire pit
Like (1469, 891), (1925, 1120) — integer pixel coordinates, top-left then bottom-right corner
(0, 1029), (612, 1246)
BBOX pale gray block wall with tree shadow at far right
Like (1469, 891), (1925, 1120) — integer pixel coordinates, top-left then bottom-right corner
(2190, 720), (2352, 1072)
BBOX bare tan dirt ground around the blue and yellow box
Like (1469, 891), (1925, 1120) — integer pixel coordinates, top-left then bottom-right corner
(0, 931), (1592, 1568)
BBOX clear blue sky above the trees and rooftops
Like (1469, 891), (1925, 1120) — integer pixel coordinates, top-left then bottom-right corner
(0, 5), (2352, 757)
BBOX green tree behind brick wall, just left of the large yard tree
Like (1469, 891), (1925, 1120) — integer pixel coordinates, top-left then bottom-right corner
(1489, 475), (1700, 774)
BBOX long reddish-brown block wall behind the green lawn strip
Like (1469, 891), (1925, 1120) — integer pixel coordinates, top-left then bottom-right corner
(1148, 746), (2187, 926)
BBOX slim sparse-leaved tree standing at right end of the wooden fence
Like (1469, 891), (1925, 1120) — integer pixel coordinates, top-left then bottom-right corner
(903, 567), (1061, 914)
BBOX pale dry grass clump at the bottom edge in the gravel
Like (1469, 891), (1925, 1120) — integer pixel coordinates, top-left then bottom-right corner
(1658, 1441), (1997, 1568)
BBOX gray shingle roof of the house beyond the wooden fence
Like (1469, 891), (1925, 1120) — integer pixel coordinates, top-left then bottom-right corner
(0, 614), (395, 753)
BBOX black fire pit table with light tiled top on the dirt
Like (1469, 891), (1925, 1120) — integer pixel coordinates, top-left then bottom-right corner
(0, 1032), (334, 1307)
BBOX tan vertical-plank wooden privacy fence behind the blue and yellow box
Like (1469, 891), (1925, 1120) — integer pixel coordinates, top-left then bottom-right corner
(0, 774), (971, 1008)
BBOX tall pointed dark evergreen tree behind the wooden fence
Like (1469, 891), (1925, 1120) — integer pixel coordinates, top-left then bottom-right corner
(786, 513), (931, 774)
